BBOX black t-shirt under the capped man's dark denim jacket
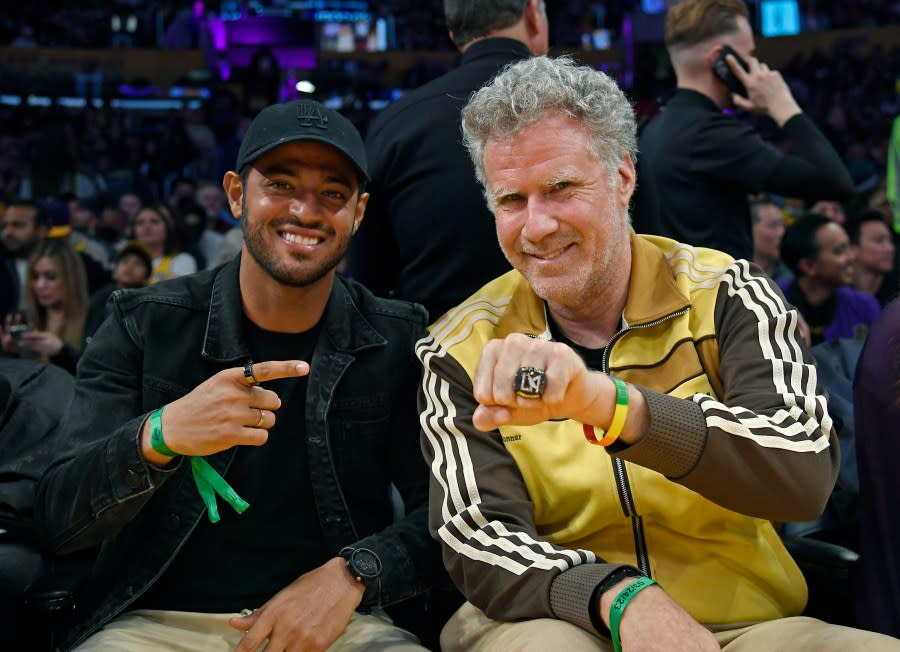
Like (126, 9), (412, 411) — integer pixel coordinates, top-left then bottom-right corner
(136, 318), (328, 613)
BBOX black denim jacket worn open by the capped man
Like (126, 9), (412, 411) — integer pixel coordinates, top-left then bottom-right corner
(36, 260), (440, 648)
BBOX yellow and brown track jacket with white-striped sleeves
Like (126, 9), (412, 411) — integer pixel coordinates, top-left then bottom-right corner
(416, 234), (839, 631)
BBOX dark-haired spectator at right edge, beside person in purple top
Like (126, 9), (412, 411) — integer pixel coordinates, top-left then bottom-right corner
(847, 210), (900, 306)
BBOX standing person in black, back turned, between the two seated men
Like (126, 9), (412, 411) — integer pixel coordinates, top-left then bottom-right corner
(349, 0), (549, 320)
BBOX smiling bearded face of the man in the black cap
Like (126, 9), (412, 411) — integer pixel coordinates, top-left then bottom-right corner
(225, 141), (369, 287)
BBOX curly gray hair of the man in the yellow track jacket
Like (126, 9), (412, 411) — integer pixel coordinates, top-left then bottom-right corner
(462, 56), (637, 194)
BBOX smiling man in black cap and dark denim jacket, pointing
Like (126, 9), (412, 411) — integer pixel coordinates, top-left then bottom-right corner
(38, 100), (440, 652)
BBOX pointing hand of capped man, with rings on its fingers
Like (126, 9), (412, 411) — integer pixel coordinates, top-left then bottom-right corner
(141, 360), (309, 466)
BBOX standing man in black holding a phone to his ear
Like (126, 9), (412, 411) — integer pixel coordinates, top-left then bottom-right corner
(633, 0), (853, 260)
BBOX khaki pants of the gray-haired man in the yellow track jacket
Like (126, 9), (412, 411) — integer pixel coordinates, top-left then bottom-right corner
(441, 602), (900, 652)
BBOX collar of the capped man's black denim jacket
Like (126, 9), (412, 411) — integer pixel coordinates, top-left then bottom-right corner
(202, 254), (387, 363)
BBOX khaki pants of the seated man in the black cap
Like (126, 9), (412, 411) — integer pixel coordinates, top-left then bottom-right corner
(75, 609), (425, 652)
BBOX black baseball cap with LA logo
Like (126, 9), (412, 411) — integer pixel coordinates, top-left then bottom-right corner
(237, 100), (369, 183)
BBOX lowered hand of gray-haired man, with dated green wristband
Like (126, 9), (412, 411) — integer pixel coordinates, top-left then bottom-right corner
(600, 577), (721, 652)
